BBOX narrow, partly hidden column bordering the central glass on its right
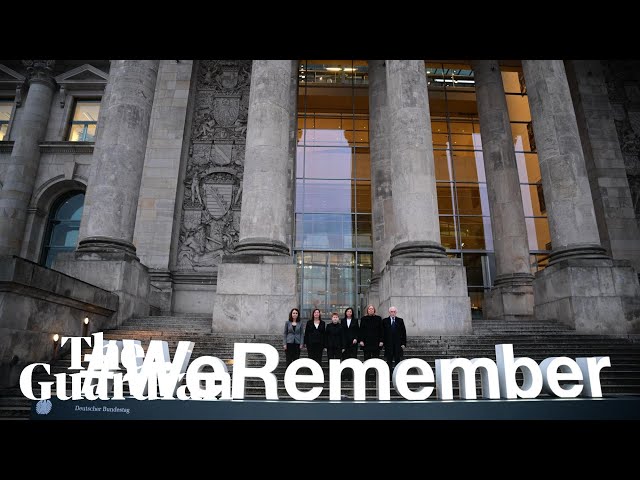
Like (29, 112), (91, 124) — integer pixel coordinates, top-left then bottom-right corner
(366, 60), (395, 306)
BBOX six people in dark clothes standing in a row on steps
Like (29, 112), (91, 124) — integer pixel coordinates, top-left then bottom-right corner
(284, 305), (407, 373)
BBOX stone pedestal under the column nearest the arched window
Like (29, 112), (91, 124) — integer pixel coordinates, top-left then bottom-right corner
(52, 248), (150, 326)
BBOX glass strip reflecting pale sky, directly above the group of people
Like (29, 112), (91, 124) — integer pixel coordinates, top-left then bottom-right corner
(295, 60), (372, 318)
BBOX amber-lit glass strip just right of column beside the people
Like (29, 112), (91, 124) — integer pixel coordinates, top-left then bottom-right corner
(426, 62), (495, 317)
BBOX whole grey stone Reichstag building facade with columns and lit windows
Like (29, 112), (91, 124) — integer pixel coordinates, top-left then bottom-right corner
(0, 60), (640, 368)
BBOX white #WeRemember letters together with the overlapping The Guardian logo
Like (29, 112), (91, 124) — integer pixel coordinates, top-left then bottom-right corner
(20, 333), (611, 400)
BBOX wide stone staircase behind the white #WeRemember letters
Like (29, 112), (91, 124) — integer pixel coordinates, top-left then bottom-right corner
(0, 315), (640, 419)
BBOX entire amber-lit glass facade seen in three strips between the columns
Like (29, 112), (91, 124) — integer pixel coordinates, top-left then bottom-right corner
(295, 60), (551, 318)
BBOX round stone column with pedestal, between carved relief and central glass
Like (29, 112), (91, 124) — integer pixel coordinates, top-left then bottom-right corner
(212, 60), (299, 333)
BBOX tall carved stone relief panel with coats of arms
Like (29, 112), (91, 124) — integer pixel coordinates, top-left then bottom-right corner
(176, 60), (251, 272)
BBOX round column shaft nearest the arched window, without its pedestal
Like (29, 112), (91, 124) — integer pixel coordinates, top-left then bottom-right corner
(78, 60), (159, 255)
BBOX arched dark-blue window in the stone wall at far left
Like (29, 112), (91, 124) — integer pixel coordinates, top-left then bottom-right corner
(40, 191), (84, 267)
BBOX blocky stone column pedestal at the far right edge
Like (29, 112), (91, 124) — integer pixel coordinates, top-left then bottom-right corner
(533, 258), (640, 334)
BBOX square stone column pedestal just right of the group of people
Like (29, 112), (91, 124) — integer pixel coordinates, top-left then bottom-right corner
(378, 258), (472, 338)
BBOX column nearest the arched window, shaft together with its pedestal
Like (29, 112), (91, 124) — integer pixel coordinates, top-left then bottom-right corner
(55, 60), (159, 325)
